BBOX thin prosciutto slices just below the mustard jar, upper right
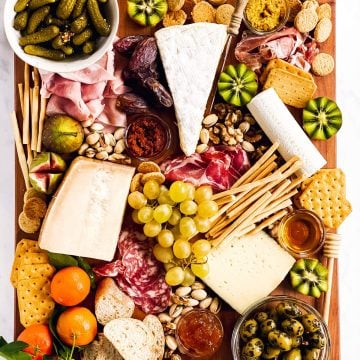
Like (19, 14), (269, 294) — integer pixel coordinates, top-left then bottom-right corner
(235, 27), (319, 71)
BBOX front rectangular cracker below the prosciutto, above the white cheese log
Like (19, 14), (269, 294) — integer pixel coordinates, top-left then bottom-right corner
(264, 68), (317, 108)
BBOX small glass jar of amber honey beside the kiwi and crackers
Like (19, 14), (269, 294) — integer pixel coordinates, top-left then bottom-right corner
(278, 209), (325, 258)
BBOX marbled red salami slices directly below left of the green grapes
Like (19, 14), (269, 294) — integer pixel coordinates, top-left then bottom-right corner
(93, 230), (171, 314)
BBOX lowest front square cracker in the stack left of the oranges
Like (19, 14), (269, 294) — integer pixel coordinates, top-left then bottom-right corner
(17, 278), (55, 327)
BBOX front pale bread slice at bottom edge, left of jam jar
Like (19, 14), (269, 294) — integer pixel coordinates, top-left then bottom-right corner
(104, 319), (157, 360)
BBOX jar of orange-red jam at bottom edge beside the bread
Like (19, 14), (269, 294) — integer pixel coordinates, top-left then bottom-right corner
(175, 309), (224, 359)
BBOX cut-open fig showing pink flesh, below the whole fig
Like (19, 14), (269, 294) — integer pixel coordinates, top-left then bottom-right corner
(29, 152), (66, 194)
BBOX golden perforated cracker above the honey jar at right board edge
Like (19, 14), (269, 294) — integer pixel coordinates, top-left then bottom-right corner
(299, 169), (352, 229)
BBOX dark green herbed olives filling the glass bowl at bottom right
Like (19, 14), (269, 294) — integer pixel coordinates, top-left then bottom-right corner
(240, 302), (327, 360)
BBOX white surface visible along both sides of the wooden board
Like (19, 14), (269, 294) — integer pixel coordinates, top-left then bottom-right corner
(0, 0), (360, 360)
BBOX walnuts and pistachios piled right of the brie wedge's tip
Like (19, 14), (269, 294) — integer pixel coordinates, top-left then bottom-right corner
(196, 103), (268, 159)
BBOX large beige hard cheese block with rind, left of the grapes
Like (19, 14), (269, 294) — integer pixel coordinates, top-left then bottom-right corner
(39, 157), (135, 261)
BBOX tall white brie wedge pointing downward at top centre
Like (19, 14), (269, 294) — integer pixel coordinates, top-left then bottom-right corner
(155, 23), (227, 156)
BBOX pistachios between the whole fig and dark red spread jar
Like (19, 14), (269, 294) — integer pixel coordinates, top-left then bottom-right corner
(78, 123), (131, 164)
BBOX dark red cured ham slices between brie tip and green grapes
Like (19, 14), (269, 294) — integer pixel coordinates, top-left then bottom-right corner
(161, 145), (250, 192)
